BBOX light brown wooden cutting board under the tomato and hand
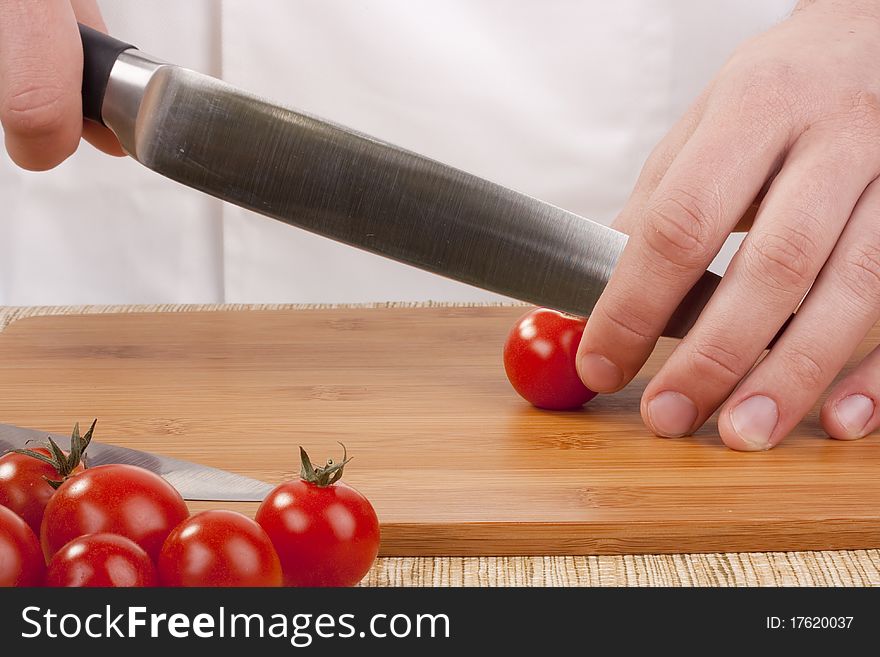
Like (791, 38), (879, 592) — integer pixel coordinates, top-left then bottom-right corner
(0, 308), (880, 555)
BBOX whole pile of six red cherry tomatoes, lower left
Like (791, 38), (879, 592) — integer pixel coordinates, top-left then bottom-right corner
(0, 423), (379, 586)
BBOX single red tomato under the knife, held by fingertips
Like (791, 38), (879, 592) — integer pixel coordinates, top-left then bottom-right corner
(504, 308), (596, 410)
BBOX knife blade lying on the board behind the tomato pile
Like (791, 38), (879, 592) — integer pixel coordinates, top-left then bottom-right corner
(0, 424), (274, 502)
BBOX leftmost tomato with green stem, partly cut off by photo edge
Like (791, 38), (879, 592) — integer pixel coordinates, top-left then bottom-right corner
(0, 447), (83, 534)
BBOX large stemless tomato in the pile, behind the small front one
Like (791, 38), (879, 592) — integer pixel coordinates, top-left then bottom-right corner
(40, 464), (189, 561)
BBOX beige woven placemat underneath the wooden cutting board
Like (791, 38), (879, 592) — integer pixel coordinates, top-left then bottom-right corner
(0, 302), (880, 586)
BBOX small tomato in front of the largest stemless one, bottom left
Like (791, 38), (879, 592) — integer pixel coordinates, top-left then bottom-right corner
(46, 534), (157, 587)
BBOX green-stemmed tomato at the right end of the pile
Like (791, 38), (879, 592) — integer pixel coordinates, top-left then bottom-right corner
(256, 449), (379, 586)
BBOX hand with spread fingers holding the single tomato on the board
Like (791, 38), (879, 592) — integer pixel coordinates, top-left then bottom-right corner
(578, 0), (880, 450)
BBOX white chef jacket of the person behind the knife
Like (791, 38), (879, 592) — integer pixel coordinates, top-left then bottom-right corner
(0, 0), (794, 305)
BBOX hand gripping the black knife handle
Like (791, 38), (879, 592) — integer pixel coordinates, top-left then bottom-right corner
(0, 0), (124, 171)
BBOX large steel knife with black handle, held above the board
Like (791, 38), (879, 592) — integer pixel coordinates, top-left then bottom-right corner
(80, 25), (721, 338)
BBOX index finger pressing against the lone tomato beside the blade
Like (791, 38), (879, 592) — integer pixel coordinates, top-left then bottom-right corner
(578, 100), (788, 392)
